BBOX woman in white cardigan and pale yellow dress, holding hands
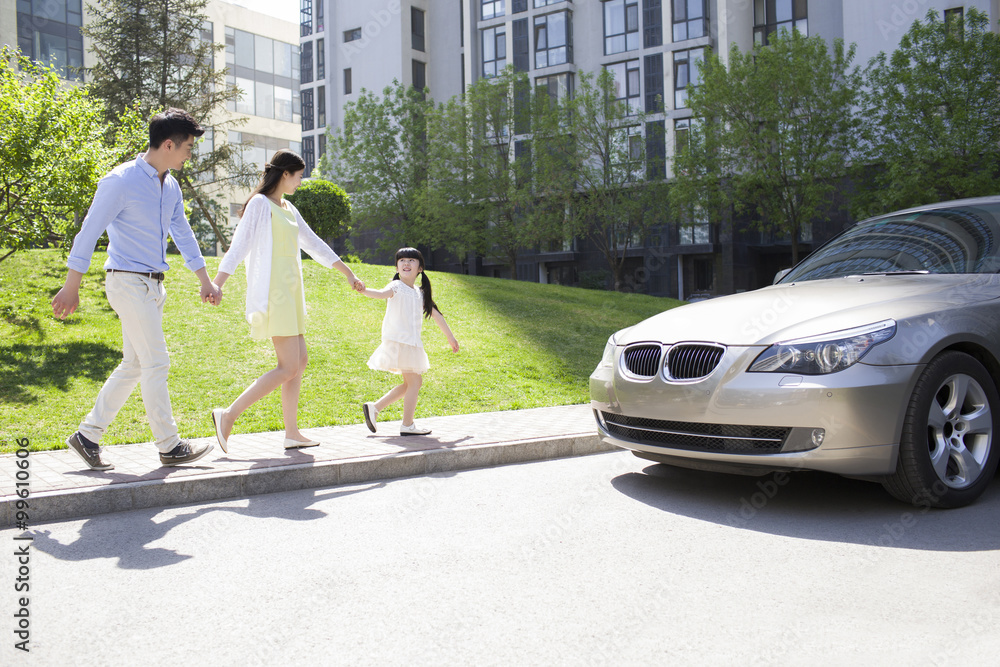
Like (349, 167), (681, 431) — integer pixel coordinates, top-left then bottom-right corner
(212, 149), (365, 453)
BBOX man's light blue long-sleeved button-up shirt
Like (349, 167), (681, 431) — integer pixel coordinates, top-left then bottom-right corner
(66, 155), (205, 273)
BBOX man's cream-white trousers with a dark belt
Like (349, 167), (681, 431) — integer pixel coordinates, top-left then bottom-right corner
(80, 273), (180, 452)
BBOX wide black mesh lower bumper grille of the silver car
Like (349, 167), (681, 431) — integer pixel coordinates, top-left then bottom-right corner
(601, 412), (791, 454)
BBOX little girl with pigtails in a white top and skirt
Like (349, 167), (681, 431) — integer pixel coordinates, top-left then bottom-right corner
(360, 248), (458, 435)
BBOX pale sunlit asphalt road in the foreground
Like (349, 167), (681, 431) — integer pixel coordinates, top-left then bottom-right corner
(0, 452), (1000, 667)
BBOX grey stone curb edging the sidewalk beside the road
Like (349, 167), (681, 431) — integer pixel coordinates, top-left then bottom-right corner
(0, 433), (615, 528)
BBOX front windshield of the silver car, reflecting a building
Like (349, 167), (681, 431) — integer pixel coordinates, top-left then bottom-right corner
(780, 202), (1000, 283)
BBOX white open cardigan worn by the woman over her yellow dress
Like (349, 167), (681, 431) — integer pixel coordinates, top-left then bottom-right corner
(219, 194), (340, 322)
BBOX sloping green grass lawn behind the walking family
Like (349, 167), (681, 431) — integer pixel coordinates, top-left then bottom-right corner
(0, 250), (681, 452)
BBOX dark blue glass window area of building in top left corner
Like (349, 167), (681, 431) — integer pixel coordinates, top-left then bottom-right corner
(16, 0), (83, 81)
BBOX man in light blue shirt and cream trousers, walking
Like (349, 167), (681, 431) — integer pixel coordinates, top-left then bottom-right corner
(52, 109), (222, 470)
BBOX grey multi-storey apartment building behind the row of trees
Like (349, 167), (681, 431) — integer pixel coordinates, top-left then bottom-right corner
(300, 0), (1000, 299)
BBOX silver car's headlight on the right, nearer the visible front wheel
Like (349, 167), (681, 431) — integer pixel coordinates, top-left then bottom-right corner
(749, 320), (896, 375)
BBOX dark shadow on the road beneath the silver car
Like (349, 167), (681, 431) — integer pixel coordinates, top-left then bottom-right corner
(611, 464), (1000, 552)
